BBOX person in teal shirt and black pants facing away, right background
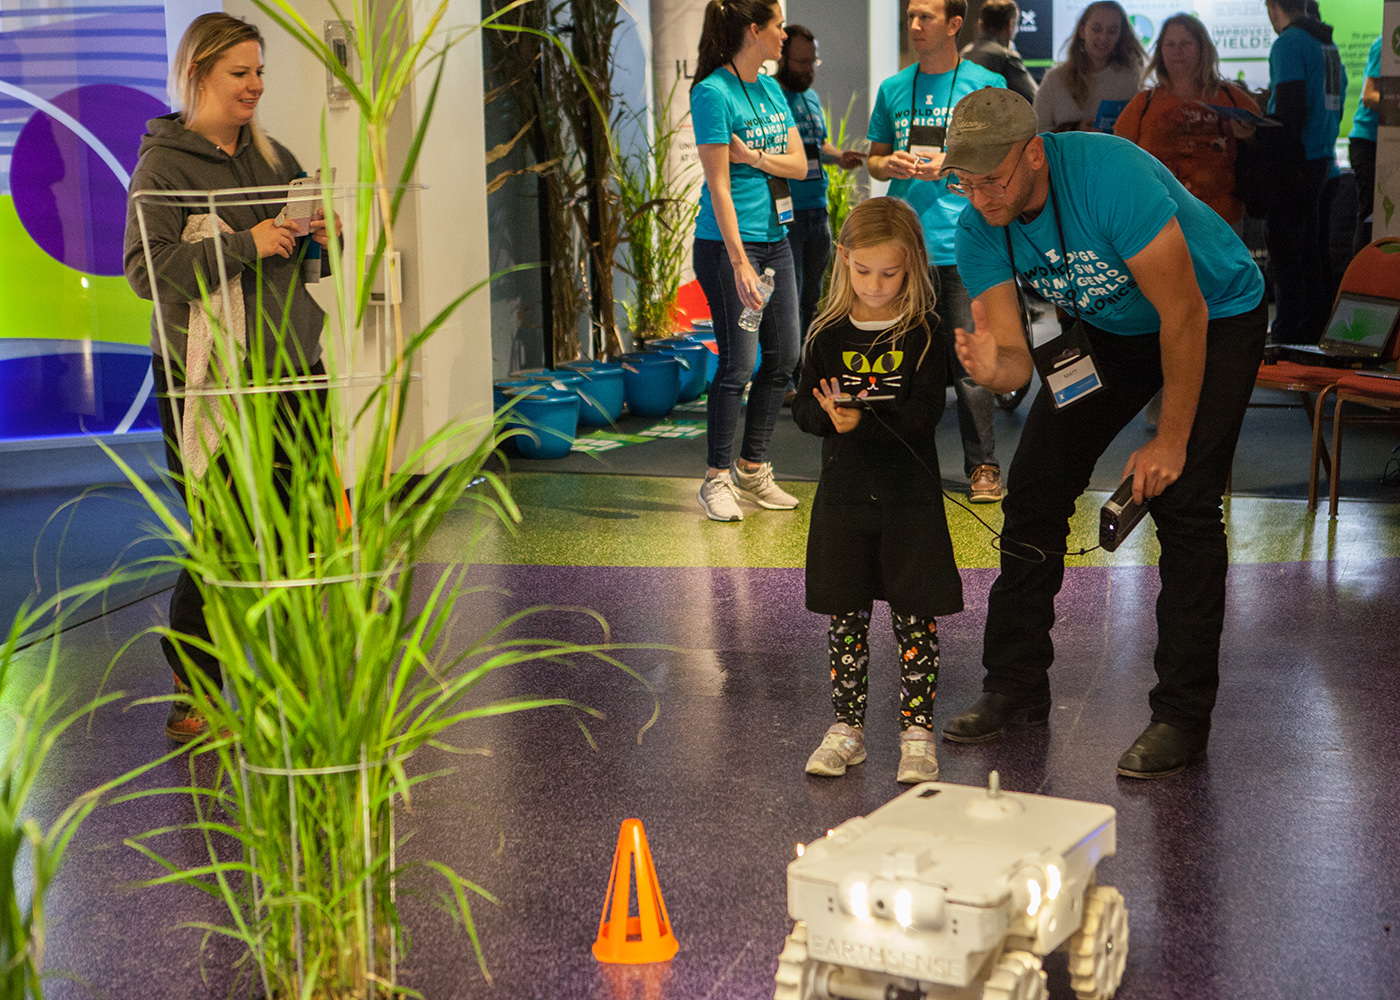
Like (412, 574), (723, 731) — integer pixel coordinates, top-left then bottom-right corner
(1257, 0), (1347, 343)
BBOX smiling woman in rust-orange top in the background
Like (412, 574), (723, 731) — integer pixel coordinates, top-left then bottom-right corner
(1113, 14), (1259, 225)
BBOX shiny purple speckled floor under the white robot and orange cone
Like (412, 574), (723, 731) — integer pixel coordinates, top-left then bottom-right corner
(19, 559), (1400, 1000)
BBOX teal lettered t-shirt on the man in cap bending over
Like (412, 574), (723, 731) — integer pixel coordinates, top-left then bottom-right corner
(958, 132), (1264, 336)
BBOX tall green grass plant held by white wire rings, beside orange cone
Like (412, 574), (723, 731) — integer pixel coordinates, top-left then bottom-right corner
(113, 0), (646, 1000)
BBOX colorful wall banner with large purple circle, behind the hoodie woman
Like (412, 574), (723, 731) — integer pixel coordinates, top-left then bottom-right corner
(0, 0), (169, 447)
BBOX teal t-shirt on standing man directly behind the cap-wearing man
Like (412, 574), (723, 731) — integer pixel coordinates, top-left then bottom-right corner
(867, 59), (1007, 263)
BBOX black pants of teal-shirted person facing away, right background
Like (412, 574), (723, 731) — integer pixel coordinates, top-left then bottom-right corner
(1267, 160), (1331, 343)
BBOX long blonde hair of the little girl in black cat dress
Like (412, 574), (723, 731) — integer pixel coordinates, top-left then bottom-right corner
(804, 197), (934, 368)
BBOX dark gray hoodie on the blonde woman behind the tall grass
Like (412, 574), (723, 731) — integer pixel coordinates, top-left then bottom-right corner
(123, 113), (325, 374)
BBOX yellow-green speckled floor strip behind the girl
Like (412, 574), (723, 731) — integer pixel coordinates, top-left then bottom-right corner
(428, 473), (1400, 569)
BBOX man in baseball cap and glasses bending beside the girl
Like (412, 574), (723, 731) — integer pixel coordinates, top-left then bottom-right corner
(944, 90), (1267, 777)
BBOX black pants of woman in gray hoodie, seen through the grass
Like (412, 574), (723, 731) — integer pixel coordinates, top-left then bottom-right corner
(151, 357), (326, 689)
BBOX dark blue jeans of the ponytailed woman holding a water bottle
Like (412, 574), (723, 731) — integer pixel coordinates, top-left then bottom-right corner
(694, 239), (801, 469)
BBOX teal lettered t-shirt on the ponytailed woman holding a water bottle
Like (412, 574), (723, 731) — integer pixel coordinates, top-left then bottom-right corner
(690, 67), (797, 244)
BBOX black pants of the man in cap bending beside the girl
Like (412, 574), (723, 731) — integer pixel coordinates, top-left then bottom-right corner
(983, 303), (1268, 732)
